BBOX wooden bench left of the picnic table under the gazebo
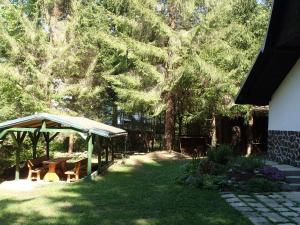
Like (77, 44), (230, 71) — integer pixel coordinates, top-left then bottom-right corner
(27, 155), (48, 180)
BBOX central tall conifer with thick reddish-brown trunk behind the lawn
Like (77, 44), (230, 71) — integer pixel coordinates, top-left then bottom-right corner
(86, 0), (206, 150)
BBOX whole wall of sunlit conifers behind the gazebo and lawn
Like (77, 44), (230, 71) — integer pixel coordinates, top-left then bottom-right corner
(0, 0), (270, 149)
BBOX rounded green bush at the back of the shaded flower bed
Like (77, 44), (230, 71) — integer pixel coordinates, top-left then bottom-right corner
(207, 145), (233, 164)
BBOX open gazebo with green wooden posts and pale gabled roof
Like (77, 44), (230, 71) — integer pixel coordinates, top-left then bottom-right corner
(0, 113), (127, 179)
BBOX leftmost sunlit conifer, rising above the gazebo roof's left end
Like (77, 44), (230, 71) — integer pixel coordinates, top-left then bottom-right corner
(0, 1), (48, 119)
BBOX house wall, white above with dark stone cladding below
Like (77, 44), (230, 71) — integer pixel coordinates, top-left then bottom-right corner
(268, 60), (300, 165)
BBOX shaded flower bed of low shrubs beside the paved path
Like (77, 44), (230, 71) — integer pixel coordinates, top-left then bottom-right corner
(176, 145), (285, 192)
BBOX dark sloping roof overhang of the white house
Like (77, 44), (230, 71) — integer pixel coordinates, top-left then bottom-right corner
(235, 0), (300, 106)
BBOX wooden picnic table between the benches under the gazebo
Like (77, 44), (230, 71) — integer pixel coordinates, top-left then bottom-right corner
(43, 157), (71, 181)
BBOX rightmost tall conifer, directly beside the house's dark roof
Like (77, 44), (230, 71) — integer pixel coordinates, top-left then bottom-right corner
(182, 0), (270, 145)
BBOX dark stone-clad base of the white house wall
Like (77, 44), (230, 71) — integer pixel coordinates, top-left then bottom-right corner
(268, 130), (300, 166)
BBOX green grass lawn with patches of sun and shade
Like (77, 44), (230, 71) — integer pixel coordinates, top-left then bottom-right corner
(0, 153), (251, 225)
